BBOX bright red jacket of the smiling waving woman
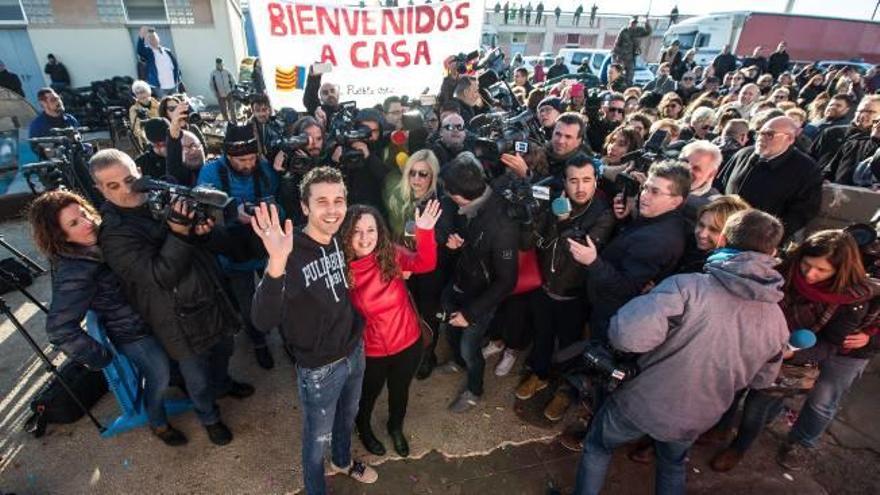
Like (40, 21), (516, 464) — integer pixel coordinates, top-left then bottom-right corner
(350, 229), (437, 357)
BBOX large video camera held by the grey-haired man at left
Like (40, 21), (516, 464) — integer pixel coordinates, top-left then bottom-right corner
(132, 177), (237, 225)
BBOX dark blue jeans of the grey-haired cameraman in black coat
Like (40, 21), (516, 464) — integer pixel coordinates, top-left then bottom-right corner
(178, 336), (234, 426)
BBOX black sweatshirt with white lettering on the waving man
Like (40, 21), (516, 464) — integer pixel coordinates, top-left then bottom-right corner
(251, 230), (363, 368)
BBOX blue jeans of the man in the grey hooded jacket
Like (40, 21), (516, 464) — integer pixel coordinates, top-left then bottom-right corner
(574, 399), (693, 495)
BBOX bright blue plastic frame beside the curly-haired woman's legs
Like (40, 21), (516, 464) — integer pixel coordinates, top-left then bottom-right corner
(86, 311), (192, 438)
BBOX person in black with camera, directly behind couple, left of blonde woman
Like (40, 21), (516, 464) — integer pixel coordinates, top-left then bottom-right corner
(331, 109), (392, 218)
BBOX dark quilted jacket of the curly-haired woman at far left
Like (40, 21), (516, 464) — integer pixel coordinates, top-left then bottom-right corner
(46, 251), (150, 369)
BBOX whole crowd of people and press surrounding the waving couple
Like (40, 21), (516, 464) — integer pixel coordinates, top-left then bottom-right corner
(18, 21), (880, 494)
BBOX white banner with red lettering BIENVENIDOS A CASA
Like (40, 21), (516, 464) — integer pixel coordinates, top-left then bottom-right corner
(250, 0), (484, 109)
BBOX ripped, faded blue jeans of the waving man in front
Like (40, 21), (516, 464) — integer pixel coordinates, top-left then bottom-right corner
(296, 341), (364, 495)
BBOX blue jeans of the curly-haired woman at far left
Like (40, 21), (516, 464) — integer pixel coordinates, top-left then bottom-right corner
(116, 335), (171, 428)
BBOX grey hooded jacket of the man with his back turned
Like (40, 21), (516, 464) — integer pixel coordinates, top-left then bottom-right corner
(609, 251), (789, 441)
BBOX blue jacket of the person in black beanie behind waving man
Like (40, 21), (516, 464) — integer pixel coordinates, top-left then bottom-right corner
(196, 155), (284, 271)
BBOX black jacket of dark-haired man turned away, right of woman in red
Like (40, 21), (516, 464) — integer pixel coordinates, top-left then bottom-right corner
(453, 192), (519, 321)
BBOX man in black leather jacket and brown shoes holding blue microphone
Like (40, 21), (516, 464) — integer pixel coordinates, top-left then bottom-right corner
(516, 153), (615, 418)
